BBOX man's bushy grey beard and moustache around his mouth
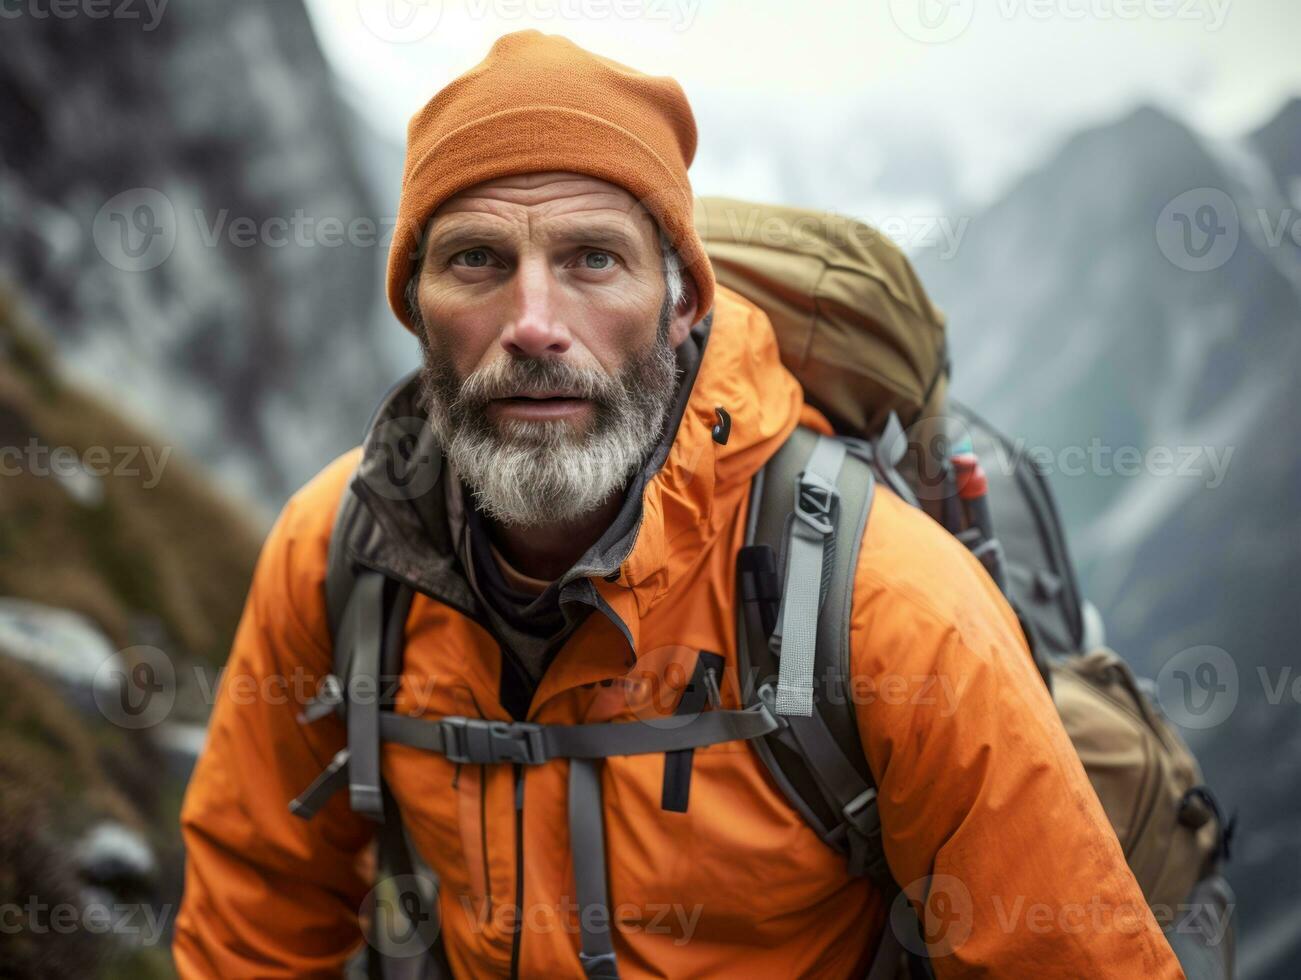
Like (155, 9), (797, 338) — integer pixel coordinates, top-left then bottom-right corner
(419, 298), (678, 527)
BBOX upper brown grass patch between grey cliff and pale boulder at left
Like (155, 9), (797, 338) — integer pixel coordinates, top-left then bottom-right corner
(0, 285), (260, 665)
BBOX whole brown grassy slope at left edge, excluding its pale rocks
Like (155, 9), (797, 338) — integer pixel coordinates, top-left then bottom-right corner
(0, 292), (262, 980)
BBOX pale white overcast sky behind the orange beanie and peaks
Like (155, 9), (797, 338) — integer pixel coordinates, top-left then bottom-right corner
(301, 0), (1301, 210)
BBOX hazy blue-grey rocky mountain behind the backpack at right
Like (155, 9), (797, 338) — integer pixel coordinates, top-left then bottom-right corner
(917, 100), (1301, 977)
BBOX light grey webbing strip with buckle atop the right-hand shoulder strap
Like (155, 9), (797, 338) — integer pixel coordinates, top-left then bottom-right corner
(771, 436), (844, 717)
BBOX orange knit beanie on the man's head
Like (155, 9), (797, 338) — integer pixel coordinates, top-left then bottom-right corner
(388, 30), (714, 329)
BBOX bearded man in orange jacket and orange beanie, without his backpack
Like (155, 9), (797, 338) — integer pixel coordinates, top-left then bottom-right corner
(174, 31), (1181, 977)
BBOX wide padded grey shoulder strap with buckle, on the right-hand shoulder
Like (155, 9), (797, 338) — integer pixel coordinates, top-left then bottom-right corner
(736, 428), (894, 890)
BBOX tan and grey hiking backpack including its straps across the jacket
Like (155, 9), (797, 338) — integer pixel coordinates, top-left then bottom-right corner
(290, 198), (1233, 980)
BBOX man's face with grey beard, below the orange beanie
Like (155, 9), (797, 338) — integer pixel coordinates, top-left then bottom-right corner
(415, 173), (696, 526)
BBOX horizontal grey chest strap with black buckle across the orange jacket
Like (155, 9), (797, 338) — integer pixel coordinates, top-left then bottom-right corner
(380, 701), (778, 765)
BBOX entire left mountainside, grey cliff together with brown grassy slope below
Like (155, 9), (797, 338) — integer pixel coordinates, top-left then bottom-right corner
(0, 0), (406, 977)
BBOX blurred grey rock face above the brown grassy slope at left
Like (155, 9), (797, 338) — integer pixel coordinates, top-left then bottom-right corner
(0, 0), (412, 514)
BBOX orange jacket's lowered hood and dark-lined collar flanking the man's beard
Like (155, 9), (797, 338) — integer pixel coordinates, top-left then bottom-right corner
(347, 282), (803, 639)
